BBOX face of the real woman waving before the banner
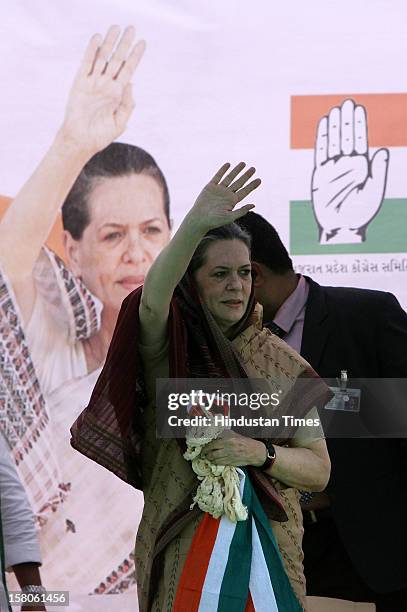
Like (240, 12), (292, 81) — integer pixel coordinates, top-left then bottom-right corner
(195, 240), (252, 332)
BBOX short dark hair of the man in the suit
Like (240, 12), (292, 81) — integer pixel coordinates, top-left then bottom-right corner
(237, 211), (294, 274)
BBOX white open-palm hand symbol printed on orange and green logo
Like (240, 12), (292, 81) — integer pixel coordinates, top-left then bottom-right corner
(312, 100), (389, 244)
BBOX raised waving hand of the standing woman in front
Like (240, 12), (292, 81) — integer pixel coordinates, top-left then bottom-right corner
(189, 162), (261, 233)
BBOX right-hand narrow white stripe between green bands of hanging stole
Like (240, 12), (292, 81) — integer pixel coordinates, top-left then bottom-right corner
(250, 518), (278, 612)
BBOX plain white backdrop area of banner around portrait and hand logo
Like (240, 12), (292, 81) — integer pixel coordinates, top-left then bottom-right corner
(0, 0), (407, 306)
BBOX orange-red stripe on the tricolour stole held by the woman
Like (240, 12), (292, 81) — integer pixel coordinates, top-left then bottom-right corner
(173, 512), (220, 612)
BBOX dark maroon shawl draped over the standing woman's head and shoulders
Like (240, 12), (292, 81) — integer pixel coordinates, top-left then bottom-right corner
(71, 275), (330, 520)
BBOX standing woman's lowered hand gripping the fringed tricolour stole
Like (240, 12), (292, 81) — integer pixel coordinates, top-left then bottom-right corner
(201, 430), (267, 467)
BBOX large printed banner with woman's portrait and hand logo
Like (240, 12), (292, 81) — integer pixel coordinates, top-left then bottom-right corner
(0, 0), (407, 611)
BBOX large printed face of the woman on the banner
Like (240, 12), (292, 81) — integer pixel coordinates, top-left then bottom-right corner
(65, 174), (170, 310)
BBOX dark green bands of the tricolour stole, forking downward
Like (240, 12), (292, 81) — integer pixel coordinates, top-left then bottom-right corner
(217, 468), (302, 612)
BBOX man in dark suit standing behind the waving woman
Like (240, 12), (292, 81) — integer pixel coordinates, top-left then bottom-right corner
(239, 212), (407, 612)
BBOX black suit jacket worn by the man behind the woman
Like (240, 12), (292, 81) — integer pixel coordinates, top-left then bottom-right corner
(301, 278), (407, 592)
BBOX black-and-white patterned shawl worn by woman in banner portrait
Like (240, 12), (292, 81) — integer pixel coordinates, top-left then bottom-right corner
(0, 248), (100, 525)
